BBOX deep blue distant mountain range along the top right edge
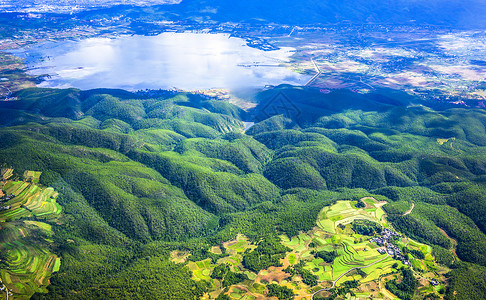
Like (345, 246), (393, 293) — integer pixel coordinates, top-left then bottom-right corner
(174, 0), (486, 27)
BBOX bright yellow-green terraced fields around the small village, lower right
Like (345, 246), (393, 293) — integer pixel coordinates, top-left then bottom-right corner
(185, 198), (448, 300)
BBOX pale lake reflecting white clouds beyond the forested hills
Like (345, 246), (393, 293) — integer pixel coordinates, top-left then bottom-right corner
(15, 33), (310, 90)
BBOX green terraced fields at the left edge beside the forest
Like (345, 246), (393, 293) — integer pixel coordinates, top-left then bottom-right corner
(0, 170), (61, 299)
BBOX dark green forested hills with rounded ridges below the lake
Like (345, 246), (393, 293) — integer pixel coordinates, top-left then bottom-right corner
(0, 86), (486, 299)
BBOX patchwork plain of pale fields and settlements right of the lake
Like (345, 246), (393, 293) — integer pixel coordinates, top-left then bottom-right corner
(275, 30), (486, 105)
